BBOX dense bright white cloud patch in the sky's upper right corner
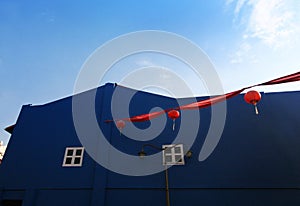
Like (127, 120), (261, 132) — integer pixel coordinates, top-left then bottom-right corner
(247, 0), (298, 48)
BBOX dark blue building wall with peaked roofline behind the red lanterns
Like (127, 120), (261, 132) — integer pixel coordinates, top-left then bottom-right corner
(0, 84), (300, 206)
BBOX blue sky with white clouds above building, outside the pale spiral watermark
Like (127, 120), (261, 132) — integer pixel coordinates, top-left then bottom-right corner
(0, 0), (300, 143)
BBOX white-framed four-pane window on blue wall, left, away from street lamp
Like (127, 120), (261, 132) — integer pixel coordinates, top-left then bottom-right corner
(62, 147), (84, 167)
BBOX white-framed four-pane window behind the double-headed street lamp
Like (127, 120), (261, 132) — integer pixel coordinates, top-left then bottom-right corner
(163, 144), (184, 165)
